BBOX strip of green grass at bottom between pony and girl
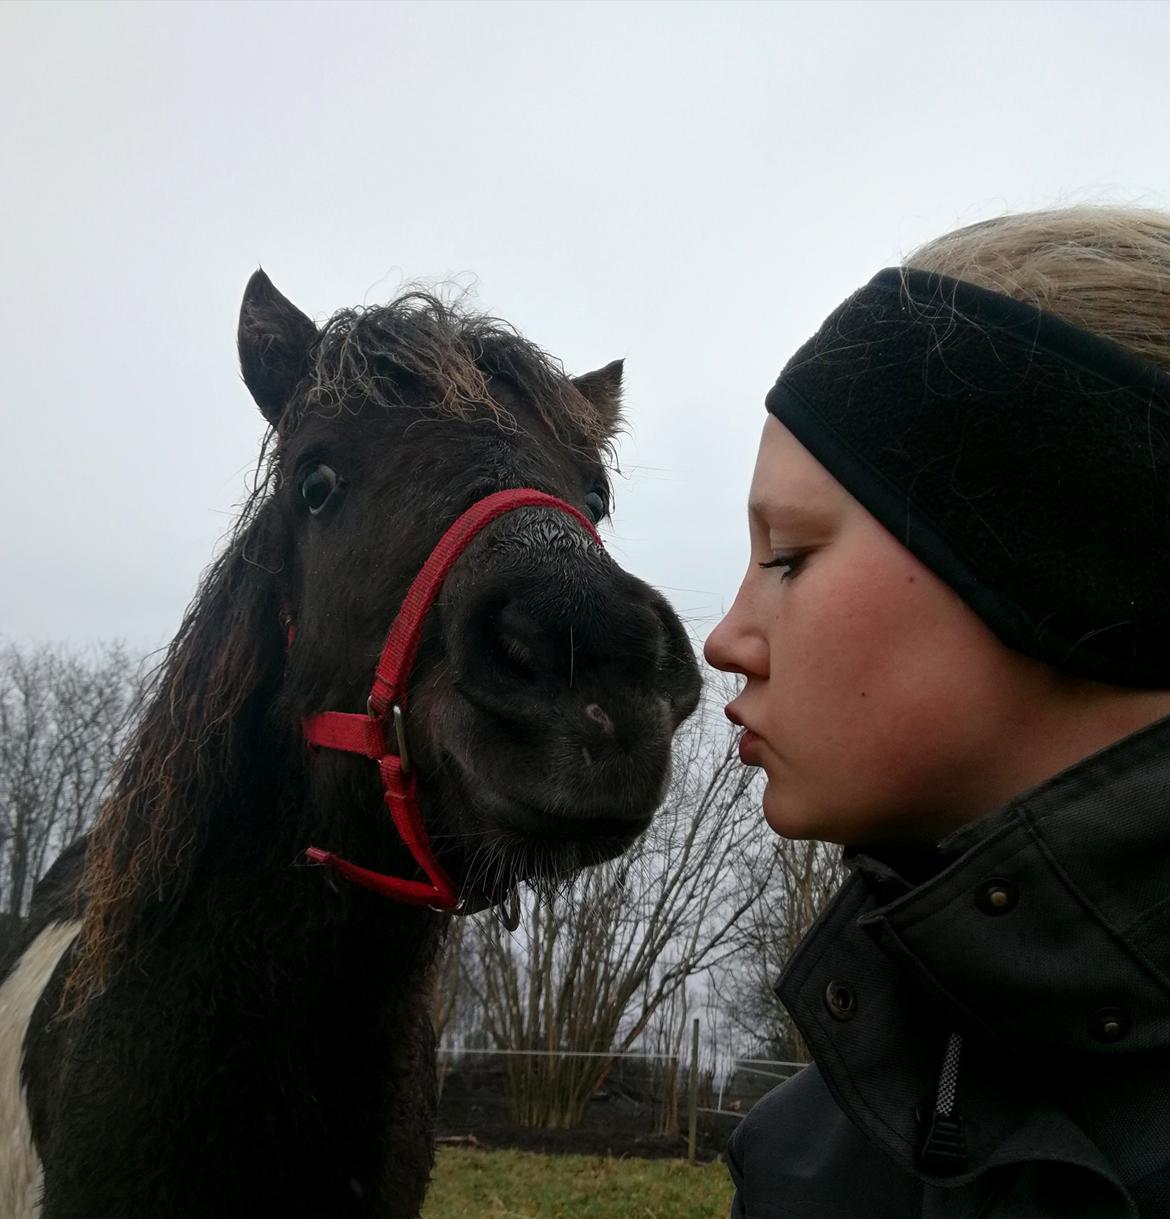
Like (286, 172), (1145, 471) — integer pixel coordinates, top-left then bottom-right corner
(422, 1147), (731, 1219)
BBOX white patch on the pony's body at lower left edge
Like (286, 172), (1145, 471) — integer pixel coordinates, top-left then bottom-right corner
(0, 923), (82, 1219)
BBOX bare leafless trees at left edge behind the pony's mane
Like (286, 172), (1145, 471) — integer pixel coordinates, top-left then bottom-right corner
(0, 644), (140, 922)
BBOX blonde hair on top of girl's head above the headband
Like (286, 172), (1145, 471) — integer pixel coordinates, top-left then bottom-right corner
(903, 206), (1170, 371)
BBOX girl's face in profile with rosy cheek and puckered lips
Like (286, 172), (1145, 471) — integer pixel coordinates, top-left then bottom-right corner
(706, 416), (1096, 844)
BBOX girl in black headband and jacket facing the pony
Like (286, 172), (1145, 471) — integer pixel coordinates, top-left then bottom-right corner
(707, 208), (1170, 1219)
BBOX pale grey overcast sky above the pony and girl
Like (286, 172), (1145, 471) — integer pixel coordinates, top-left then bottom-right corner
(0, 0), (1170, 649)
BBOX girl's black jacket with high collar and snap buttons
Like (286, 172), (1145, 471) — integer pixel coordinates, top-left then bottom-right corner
(728, 719), (1170, 1219)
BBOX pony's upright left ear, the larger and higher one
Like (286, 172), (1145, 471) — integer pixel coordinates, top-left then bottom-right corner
(236, 271), (317, 427)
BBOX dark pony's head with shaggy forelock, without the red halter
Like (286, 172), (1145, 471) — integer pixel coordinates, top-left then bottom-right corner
(239, 273), (698, 889)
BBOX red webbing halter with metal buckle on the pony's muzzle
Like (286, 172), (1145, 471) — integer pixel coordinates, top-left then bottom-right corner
(302, 489), (602, 909)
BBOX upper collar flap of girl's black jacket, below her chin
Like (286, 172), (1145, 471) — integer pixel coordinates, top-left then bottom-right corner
(854, 719), (1170, 1057)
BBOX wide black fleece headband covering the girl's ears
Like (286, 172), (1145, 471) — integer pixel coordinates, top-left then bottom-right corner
(767, 267), (1170, 689)
